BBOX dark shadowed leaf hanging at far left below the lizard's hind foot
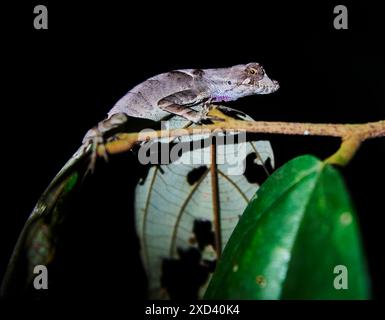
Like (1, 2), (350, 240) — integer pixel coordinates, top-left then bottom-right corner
(0, 145), (89, 299)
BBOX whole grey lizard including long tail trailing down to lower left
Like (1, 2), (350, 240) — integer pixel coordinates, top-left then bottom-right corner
(1, 63), (279, 295)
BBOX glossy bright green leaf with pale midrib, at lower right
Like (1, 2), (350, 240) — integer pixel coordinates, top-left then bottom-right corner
(205, 156), (369, 299)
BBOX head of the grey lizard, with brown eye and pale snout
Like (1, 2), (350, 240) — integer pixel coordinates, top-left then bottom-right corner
(234, 62), (279, 96)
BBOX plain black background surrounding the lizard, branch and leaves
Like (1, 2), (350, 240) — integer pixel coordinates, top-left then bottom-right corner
(0, 1), (385, 310)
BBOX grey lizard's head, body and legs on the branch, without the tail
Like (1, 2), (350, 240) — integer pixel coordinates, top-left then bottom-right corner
(83, 62), (279, 171)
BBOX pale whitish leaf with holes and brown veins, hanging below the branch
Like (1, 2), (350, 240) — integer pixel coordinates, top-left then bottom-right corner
(135, 109), (274, 298)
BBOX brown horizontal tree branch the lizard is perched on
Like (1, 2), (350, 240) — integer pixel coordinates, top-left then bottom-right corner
(98, 108), (385, 165)
